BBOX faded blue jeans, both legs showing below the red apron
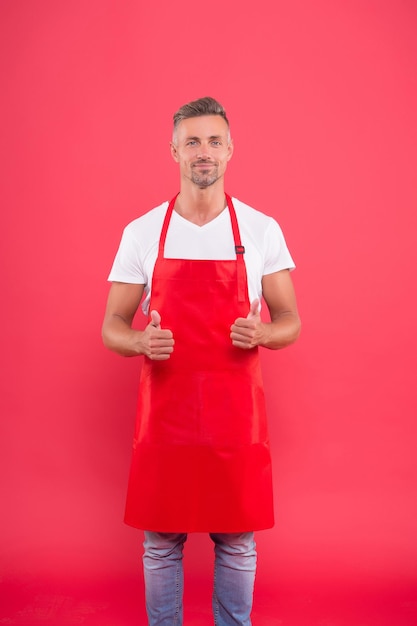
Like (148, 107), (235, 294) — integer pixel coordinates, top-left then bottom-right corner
(143, 531), (256, 626)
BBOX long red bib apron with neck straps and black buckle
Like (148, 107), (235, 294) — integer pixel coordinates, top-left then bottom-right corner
(125, 195), (274, 532)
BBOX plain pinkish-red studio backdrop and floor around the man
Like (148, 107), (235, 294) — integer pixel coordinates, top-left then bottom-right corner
(0, 0), (417, 626)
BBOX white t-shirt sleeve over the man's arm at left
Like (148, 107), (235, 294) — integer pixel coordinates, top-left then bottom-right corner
(108, 226), (147, 285)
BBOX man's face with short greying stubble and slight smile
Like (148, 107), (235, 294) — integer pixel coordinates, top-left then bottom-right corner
(171, 115), (233, 189)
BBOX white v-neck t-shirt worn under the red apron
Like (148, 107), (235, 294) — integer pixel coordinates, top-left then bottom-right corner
(108, 198), (295, 315)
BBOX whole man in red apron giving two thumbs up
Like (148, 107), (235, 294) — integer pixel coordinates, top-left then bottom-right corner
(103, 98), (300, 626)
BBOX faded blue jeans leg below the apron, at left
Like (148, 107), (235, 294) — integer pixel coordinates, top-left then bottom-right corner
(143, 531), (187, 626)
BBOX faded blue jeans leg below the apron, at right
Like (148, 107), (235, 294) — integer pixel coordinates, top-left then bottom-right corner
(210, 532), (256, 626)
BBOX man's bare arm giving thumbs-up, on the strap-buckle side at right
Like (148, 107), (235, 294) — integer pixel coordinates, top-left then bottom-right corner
(230, 270), (301, 350)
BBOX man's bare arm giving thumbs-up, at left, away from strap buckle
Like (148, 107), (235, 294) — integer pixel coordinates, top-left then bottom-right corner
(102, 282), (174, 360)
